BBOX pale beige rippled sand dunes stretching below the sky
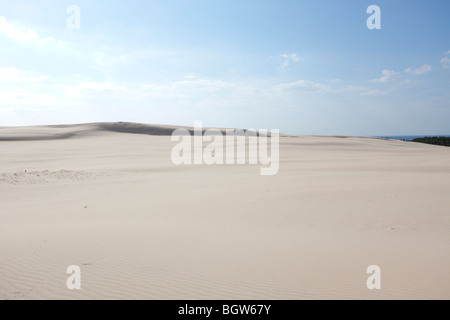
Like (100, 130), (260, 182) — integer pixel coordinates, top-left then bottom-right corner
(0, 124), (450, 299)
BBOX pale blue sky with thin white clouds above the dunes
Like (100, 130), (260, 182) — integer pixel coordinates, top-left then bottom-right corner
(0, 0), (450, 136)
